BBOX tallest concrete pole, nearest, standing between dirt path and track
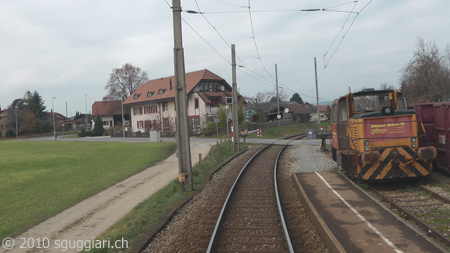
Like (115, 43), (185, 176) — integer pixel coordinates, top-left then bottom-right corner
(172, 0), (194, 191)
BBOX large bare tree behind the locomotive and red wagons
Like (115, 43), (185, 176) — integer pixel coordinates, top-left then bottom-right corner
(400, 38), (450, 103)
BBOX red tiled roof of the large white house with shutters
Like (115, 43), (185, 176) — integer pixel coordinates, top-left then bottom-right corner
(123, 69), (229, 105)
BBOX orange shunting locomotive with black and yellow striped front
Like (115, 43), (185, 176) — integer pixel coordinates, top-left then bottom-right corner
(330, 89), (436, 181)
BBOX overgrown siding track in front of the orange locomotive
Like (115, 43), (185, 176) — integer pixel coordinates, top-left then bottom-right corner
(371, 185), (450, 246)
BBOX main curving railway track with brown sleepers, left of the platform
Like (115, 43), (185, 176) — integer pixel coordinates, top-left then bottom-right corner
(207, 142), (294, 252)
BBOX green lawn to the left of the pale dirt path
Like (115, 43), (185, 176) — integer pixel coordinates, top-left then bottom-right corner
(0, 140), (176, 239)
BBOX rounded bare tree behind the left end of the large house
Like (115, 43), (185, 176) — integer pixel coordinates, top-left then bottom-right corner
(103, 63), (148, 101)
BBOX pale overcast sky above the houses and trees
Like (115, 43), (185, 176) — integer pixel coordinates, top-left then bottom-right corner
(0, 0), (450, 117)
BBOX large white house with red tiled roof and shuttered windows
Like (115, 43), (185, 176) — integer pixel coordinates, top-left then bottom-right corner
(123, 69), (246, 134)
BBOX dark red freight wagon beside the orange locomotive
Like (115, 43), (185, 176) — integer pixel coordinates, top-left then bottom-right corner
(414, 102), (450, 173)
